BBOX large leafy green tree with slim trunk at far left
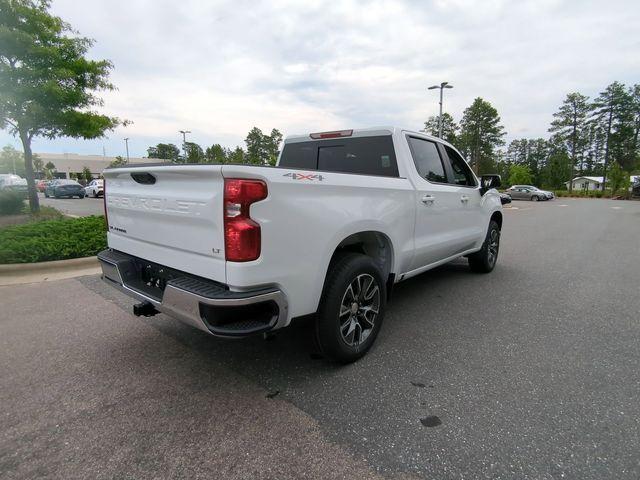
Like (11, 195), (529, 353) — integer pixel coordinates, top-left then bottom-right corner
(0, 0), (127, 212)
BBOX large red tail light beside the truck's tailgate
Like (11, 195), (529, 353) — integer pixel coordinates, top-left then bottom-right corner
(224, 178), (267, 262)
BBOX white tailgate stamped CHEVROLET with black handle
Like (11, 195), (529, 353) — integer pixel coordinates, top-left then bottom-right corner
(104, 165), (226, 282)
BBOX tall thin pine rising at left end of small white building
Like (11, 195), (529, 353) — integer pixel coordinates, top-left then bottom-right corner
(549, 92), (593, 191)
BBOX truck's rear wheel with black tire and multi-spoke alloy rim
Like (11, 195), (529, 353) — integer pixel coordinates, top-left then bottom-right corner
(315, 253), (387, 364)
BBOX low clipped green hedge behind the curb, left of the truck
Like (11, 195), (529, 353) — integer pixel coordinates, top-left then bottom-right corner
(0, 217), (107, 264)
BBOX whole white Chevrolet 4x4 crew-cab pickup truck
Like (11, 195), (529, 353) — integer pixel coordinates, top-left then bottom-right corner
(98, 127), (502, 362)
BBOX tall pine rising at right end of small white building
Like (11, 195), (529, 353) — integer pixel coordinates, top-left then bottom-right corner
(593, 82), (635, 190)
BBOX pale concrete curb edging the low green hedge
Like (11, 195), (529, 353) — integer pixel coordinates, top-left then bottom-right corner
(0, 257), (101, 286)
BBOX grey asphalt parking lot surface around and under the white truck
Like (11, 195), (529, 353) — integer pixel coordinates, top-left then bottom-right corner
(0, 199), (640, 479)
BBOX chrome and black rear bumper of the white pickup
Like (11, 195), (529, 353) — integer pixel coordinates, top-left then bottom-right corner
(98, 249), (287, 337)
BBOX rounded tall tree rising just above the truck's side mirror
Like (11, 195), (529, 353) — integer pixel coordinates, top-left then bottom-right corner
(457, 97), (506, 174)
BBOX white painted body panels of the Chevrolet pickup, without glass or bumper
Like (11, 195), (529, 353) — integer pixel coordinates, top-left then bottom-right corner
(104, 127), (502, 324)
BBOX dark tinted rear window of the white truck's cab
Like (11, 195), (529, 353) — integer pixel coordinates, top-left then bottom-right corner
(279, 135), (398, 177)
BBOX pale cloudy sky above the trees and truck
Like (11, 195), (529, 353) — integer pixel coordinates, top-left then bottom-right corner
(0, 0), (640, 157)
